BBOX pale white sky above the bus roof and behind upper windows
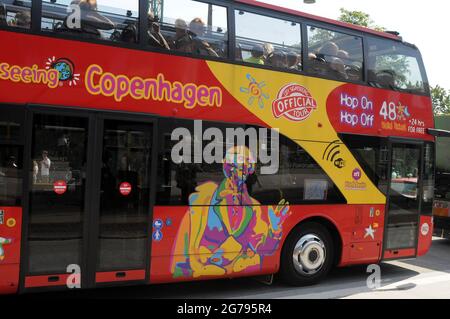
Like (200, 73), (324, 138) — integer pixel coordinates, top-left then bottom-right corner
(98, 0), (450, 89)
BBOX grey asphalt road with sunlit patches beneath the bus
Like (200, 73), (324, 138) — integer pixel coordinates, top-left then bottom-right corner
(22, 239), (450, 299)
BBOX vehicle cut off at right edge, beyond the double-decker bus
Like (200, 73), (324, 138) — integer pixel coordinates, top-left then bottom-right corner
(433, 115), (450, 239)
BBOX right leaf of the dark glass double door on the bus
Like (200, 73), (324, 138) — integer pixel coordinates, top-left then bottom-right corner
(91, 117), (155, 285)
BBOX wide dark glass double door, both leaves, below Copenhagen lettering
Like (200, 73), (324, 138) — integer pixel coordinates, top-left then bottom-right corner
(23, 109), (154, 289)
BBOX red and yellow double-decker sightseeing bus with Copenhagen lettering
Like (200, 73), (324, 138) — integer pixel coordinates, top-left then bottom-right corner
(0, 0), (435, 294)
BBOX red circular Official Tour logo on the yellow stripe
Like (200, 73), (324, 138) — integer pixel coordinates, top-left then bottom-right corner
(272, 83), (317, 122)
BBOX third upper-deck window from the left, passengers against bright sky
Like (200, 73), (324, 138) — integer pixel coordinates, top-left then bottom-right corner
(158, 0), (228, 57)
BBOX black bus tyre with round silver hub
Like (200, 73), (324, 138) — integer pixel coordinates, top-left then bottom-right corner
(280, 222), (335, 286)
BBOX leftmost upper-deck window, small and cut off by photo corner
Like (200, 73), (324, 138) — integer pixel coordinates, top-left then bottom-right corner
(0, 0), (31, 29)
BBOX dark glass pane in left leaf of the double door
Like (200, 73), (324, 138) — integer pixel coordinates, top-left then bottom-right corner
(27, 114), (88, 274)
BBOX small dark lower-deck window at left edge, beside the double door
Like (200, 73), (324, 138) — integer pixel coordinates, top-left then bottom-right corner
(0, 146), (22, 206)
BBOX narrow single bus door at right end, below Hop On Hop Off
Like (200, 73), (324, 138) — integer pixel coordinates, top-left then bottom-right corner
(383, 140), (423, 259)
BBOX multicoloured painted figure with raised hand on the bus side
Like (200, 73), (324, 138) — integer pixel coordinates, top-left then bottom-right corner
(171, 147), (290, 278)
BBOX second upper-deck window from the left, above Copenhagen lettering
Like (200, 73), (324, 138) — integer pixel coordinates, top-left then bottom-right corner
(41, 0), (139, 43)
